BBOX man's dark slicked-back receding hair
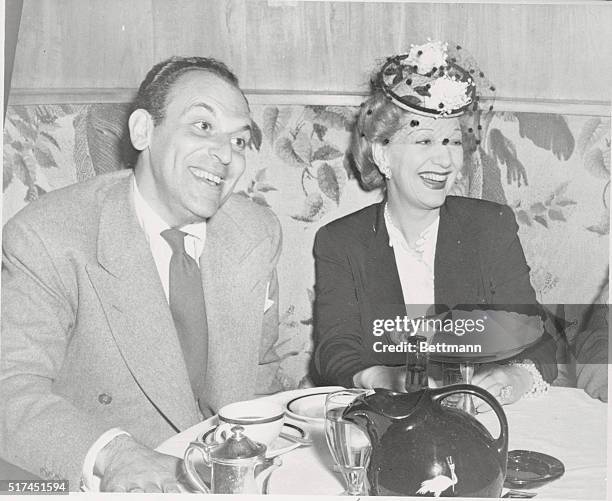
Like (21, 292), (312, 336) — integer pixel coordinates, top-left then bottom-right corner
(134, 56), (242, 125)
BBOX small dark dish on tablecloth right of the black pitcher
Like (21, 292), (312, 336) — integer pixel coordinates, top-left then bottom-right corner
(504, 450), (565, 489)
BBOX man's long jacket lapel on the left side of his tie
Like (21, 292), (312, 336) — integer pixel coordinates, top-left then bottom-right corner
(88, 176), (198, 430)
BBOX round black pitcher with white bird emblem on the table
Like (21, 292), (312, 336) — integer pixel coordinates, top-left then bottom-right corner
(343, 384), (508, 497)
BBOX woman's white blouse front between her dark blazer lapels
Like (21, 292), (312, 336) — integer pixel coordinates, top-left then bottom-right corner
(385, 205), (440, 317)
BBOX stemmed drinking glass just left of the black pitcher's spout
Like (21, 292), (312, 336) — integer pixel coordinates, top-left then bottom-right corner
(325, 389), (372, 496)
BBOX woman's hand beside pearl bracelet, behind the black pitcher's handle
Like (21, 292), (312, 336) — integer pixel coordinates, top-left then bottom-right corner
(472, 364), (533, 412)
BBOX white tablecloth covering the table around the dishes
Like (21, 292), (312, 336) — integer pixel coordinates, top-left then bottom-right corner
(157, 387), (607, 499)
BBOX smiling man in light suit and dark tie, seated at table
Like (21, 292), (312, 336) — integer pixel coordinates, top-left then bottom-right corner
(0, 57), (280, 492)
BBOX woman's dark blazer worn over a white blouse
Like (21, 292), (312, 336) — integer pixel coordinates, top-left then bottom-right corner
(313, 196), (557, 387)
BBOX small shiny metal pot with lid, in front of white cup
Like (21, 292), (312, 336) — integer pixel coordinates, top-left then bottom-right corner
(185, 426), (281, 494)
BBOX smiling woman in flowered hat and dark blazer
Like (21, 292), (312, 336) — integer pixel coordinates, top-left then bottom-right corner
(314, 42), (556, 403)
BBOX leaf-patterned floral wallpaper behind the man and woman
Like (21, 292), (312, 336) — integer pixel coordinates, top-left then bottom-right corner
(3, 104), (610, 388)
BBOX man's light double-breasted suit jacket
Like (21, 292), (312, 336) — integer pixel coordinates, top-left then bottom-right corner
(0, 171), (280, 489)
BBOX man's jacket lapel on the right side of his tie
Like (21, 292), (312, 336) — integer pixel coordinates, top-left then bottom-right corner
(200, 199), (266, 412)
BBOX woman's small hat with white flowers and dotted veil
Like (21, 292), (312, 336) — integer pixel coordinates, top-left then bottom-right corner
(380, 40), (495, 117)
